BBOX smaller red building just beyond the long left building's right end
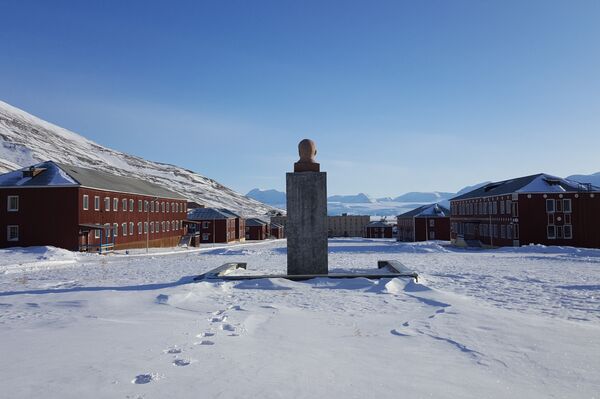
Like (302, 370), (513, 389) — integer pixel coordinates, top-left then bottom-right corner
(185, 208), (240, 243)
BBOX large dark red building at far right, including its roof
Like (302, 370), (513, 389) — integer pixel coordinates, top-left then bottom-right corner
(450, 174), (600, 248)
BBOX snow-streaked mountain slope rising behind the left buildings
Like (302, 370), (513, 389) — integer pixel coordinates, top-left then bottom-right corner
(0, 101), (273, 216)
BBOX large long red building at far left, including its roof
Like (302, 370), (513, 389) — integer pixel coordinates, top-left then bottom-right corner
(0, 161), (186, 251)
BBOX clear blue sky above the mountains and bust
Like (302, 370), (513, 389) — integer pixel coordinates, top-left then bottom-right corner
(0, 0), (600, 196)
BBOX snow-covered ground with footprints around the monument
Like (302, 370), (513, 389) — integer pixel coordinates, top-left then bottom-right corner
(0, 239), (600, 398)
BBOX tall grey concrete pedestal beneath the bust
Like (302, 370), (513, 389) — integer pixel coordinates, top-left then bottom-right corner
(286, 172), (328, 275)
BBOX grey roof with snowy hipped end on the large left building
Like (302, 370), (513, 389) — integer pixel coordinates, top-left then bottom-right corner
(0, 161), (185, 199)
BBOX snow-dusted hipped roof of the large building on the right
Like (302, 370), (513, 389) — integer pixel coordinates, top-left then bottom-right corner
(450, 173), (600, 201)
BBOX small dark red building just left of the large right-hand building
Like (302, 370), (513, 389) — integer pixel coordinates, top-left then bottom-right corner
(397, 204), (450, 241)
